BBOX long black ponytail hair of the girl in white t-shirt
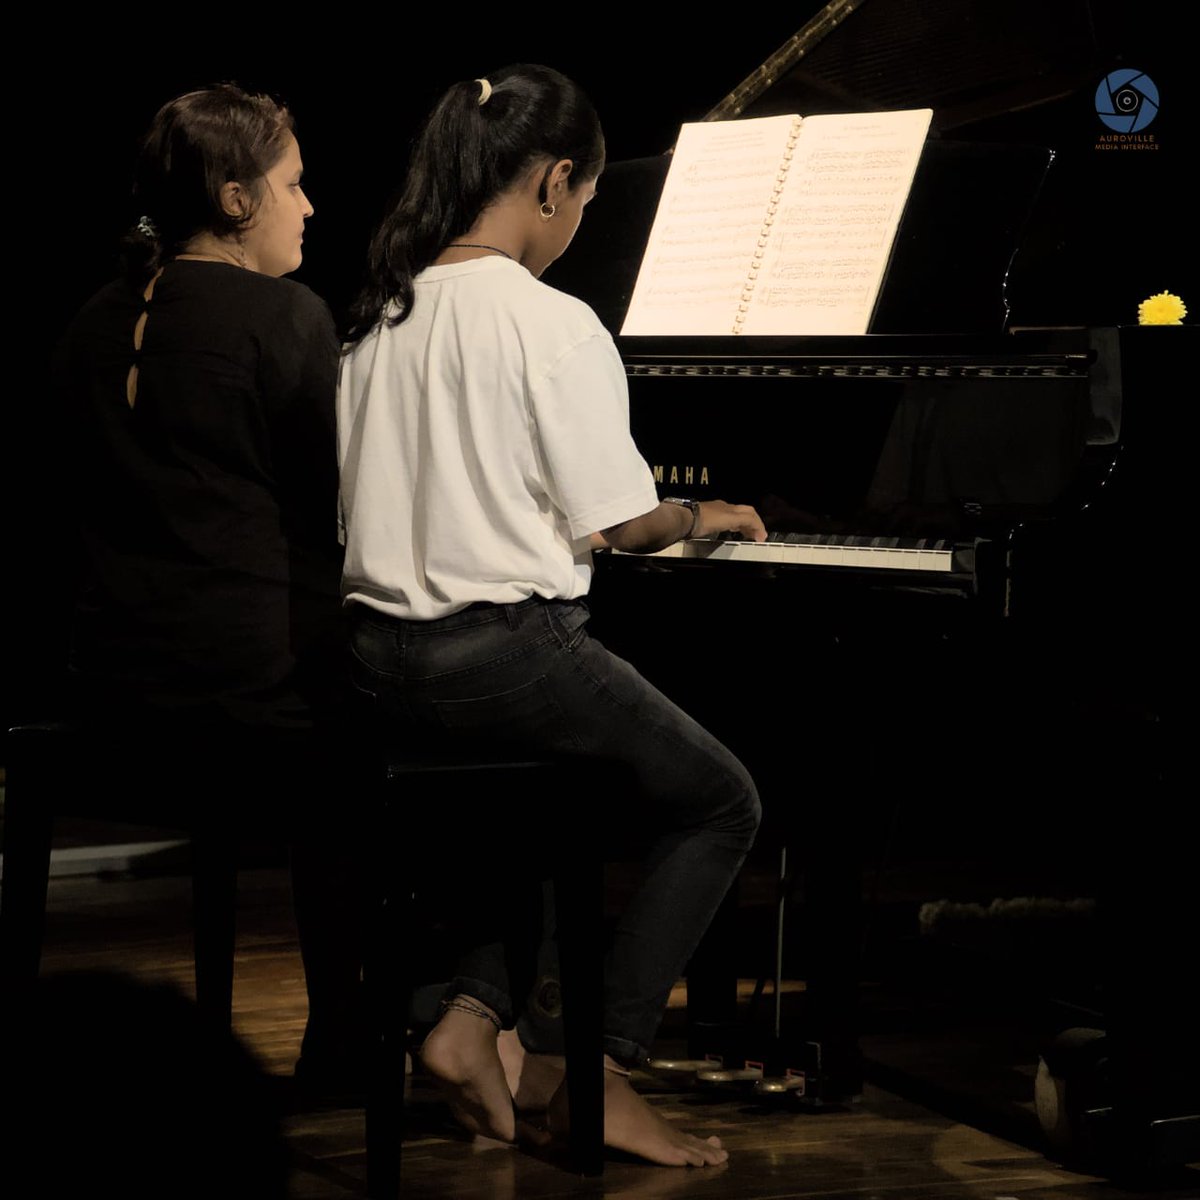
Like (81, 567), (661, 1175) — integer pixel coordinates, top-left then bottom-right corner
(346, 64), (605, 343)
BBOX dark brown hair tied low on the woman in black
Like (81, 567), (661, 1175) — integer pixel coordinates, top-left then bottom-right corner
(121, 83), (294, 282)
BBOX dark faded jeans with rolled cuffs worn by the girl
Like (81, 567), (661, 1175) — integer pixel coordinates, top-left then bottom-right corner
(350, 599), (761, 1063)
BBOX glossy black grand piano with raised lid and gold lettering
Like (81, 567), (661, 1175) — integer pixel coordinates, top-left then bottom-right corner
(546, 0), (1200, 1166)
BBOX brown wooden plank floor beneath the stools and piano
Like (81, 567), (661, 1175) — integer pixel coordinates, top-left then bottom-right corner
(11, 830), (1200, 1200)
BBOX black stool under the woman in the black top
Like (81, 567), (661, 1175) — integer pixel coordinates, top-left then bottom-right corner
(0, 721), (322, 1026)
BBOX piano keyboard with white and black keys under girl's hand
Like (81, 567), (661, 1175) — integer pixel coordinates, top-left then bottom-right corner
(614, 533), (970, 572)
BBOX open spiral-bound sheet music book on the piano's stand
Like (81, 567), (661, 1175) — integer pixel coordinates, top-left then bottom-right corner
(620, 108), (934, 335)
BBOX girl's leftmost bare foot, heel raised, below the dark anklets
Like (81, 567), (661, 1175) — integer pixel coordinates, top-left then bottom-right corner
(420, 997), (516, 1141)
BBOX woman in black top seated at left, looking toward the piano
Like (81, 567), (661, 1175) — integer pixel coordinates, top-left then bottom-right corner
(55, 84), (358, 1089)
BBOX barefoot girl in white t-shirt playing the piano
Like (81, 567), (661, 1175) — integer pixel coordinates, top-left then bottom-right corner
(337, 66), (766, 1165)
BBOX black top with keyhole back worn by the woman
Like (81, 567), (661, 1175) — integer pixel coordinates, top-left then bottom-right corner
(56, 260), (341, 726)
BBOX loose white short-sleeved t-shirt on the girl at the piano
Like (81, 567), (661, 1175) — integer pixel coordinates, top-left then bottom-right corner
(337, 258), (658, 620)
